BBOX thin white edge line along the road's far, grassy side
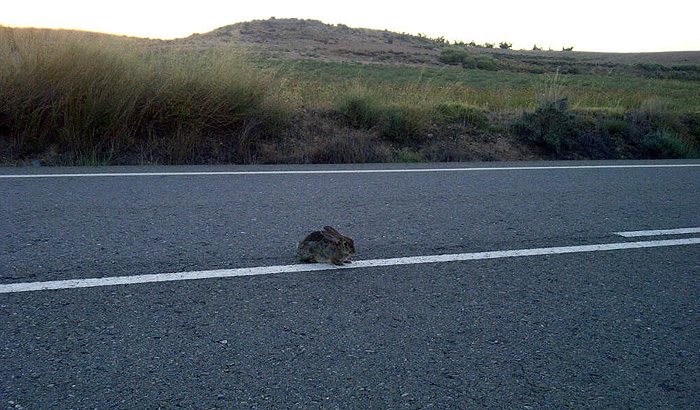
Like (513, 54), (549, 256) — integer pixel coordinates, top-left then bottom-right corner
(0, 163), (700, 179)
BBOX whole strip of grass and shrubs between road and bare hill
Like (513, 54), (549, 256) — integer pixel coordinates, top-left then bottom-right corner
(0, 27), (700, 165)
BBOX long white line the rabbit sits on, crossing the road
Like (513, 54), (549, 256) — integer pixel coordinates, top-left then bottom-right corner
(0, 238), (700, 293)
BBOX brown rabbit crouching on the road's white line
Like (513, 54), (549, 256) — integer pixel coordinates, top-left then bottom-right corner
(297, 226), (355, 266)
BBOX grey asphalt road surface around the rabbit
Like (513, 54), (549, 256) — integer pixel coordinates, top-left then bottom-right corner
(0, 161), (700, 410)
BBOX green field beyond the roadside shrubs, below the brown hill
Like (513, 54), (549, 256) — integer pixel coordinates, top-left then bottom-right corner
(269, 60), (700, 113)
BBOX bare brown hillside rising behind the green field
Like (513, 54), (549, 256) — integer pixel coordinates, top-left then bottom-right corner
(175, 18), (700, 72)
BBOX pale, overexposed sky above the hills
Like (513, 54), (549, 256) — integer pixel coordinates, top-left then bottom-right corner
(0, 0), (700, 52)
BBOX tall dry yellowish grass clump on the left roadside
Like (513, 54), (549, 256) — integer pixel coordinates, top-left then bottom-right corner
(0, 27), (282, 164)
